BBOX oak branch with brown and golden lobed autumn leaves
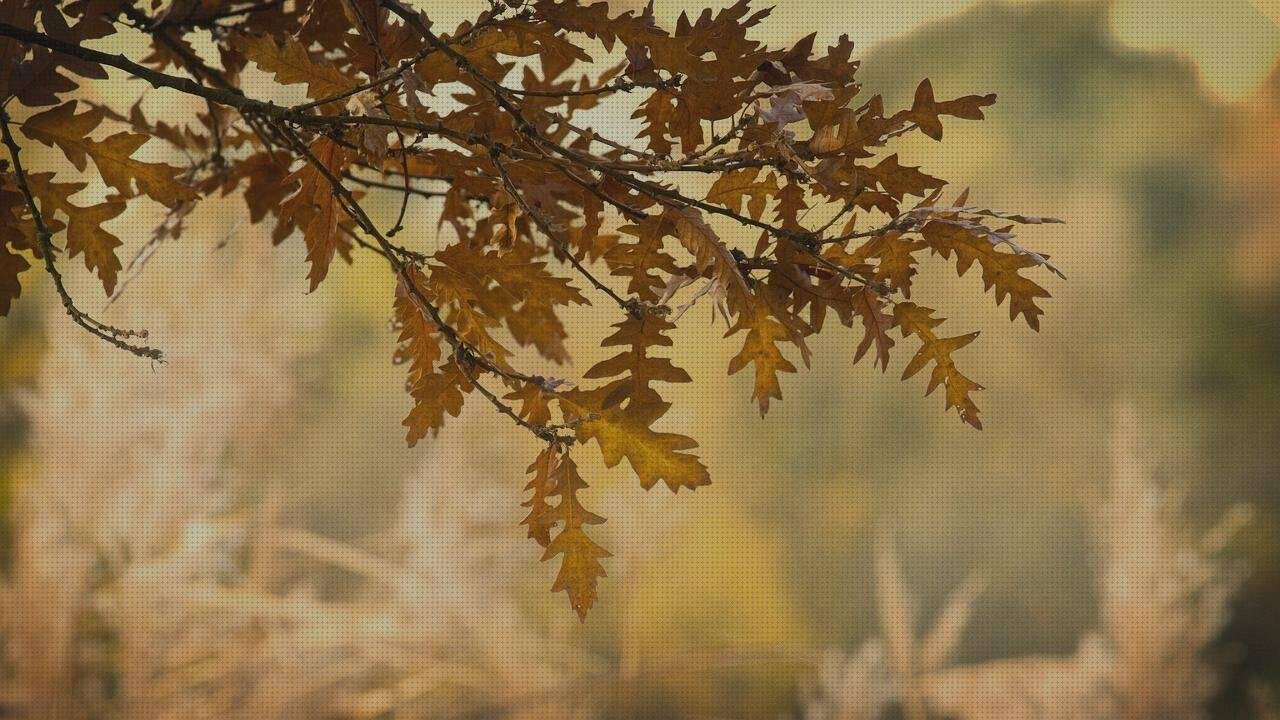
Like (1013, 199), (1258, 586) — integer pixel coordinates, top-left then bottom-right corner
(0, 0), (1057, 616)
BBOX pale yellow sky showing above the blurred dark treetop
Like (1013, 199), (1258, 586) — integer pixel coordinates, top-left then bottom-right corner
(645, 0), (1280, 101)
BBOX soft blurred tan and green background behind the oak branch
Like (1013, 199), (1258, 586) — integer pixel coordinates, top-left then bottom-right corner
(0, 0), (1280, 720)
